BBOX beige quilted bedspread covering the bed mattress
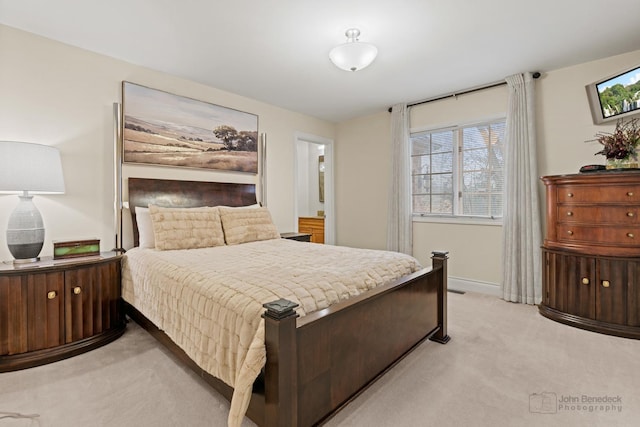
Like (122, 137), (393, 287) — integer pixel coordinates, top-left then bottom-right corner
(122, 239), (420, 427)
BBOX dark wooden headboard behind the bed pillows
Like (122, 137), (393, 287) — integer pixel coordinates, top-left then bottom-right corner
(128, 178), (256, 246)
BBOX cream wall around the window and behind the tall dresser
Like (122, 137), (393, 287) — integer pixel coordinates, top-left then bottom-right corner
(336, 50), (640, 292)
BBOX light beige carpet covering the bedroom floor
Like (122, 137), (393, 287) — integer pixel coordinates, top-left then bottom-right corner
(0, 293), (640, 427)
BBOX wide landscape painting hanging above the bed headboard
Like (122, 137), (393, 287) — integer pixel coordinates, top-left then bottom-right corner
(122, 82), (258, 173)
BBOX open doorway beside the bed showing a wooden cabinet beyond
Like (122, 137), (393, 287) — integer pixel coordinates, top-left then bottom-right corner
(295, 133), (335, 245)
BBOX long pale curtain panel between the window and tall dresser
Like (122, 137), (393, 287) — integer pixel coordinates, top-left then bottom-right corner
(502, 73), (542, 304)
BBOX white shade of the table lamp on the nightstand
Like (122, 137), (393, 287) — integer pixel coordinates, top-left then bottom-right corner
(0, 141), (64, 194)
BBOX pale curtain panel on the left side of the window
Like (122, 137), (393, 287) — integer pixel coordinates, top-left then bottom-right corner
(387, 104), (413, 255)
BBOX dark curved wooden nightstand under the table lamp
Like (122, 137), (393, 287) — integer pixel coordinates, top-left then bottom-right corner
(0, 252), (125, 372)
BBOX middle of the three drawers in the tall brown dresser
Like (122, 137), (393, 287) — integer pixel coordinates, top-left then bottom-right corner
(558, 204), (640, 224)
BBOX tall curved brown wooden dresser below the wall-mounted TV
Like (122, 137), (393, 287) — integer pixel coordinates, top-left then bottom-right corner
(539, 170), (640, 339)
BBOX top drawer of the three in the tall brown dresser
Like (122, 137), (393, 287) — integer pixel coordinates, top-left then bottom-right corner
(558, 184), (640, 204)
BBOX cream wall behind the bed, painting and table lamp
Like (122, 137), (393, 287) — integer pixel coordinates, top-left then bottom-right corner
(0, 25), (335, 260)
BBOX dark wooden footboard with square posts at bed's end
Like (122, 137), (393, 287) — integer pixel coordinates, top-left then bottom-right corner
(259, 252), (450, 427)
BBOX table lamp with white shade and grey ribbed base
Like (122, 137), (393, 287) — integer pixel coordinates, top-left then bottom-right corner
(0, 141), (64, 264)
